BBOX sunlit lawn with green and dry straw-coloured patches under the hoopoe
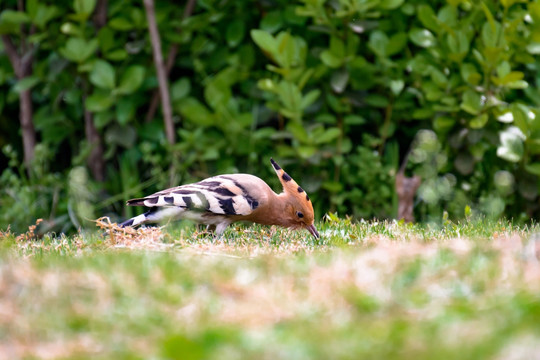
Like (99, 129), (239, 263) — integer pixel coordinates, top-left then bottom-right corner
(0, 217), (540, 360)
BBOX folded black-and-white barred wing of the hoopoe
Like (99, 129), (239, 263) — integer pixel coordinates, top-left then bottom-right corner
(127, 174), (266, 216)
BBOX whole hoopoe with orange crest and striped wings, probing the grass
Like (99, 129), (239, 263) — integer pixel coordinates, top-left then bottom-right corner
(120, 159), (319, 238)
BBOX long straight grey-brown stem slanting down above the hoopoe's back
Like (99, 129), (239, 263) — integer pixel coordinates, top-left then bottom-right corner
(144, 0), (176, 144)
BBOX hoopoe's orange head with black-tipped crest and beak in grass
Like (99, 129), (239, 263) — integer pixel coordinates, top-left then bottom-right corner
(270, 159), (320, 239)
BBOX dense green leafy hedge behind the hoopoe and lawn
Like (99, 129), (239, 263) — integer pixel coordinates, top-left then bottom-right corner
(0, 0), (540, 231)
